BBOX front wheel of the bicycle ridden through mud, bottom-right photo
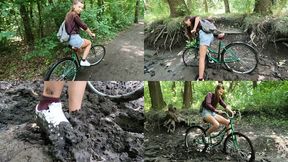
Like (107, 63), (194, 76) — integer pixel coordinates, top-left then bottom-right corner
(224, 132), (255, 162)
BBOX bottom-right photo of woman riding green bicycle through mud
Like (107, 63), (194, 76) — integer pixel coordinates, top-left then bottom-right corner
(144, 81), (288, 162)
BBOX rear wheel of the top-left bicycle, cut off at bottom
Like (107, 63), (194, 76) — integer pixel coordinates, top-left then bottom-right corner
(44, 58), (78, 81)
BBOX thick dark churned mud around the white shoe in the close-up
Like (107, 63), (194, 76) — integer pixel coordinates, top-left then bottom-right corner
(0, 81), (144, 162)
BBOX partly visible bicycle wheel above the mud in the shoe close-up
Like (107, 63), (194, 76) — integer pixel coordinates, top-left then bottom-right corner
(88, 81), (144, 101)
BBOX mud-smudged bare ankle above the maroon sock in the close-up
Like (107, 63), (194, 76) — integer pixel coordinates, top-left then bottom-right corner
(43, 81), (64, 98)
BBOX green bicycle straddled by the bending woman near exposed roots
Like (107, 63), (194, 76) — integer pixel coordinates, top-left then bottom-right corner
(182, 37), (258, 74)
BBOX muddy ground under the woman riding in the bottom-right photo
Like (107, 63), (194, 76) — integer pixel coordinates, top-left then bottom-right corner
(144, 112), (288, 162)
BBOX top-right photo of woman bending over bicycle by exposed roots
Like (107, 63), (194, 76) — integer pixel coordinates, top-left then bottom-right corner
(144, 0), (288, 81)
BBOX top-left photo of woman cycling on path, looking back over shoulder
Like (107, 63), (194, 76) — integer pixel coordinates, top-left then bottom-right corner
(0, 0), (144, 81)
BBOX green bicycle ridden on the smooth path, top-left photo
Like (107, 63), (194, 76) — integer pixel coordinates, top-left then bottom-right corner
(44, 37), (106, 81)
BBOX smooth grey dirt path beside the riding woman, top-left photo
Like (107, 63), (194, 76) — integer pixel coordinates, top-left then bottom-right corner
(78, 22), (144, 81)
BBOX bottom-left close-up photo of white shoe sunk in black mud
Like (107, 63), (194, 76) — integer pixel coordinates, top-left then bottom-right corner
(0, 81), (144, 162)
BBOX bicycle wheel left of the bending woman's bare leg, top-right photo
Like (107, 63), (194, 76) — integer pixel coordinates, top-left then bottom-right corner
(182, 48), (199, 67)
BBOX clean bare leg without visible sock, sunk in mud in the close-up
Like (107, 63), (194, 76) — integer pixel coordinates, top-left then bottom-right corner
(68, 81), (87, 112)
